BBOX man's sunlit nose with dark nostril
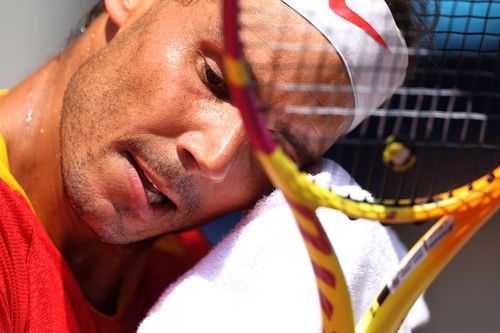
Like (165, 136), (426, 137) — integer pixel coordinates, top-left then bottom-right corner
(176, 116), (245, 183)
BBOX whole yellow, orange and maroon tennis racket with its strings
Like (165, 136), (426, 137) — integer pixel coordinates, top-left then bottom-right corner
(223, 0), (500, 333)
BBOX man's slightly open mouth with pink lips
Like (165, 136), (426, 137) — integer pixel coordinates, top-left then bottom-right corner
(127, 154), (177, 221)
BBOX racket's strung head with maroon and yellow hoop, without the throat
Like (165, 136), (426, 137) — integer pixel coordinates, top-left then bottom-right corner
(225, 0), (500, 222)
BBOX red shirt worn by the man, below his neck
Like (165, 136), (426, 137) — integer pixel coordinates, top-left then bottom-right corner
(0, 170), (209, 333)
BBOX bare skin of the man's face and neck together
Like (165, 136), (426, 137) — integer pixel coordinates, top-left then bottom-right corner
(0, 0), (349, 308)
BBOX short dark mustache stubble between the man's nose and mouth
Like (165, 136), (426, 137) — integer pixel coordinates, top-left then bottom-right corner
(125, 138), (200, 215)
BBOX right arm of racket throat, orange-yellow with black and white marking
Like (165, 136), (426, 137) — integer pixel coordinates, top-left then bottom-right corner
(356, 182), (500, 333)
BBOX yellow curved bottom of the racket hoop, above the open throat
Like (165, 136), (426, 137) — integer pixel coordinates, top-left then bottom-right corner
(257, 146), (500, 223)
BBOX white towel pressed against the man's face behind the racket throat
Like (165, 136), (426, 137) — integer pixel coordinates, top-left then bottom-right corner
(139, 160), (429, 333)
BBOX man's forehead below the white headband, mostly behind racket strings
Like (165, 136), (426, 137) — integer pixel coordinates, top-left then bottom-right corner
(150, 0), (352, 161)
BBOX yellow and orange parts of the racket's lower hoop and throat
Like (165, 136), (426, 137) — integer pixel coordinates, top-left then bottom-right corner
(257, 146), (500, 333)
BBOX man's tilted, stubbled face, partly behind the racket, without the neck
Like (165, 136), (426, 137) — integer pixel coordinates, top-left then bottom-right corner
(61, 0), (352, 243)
